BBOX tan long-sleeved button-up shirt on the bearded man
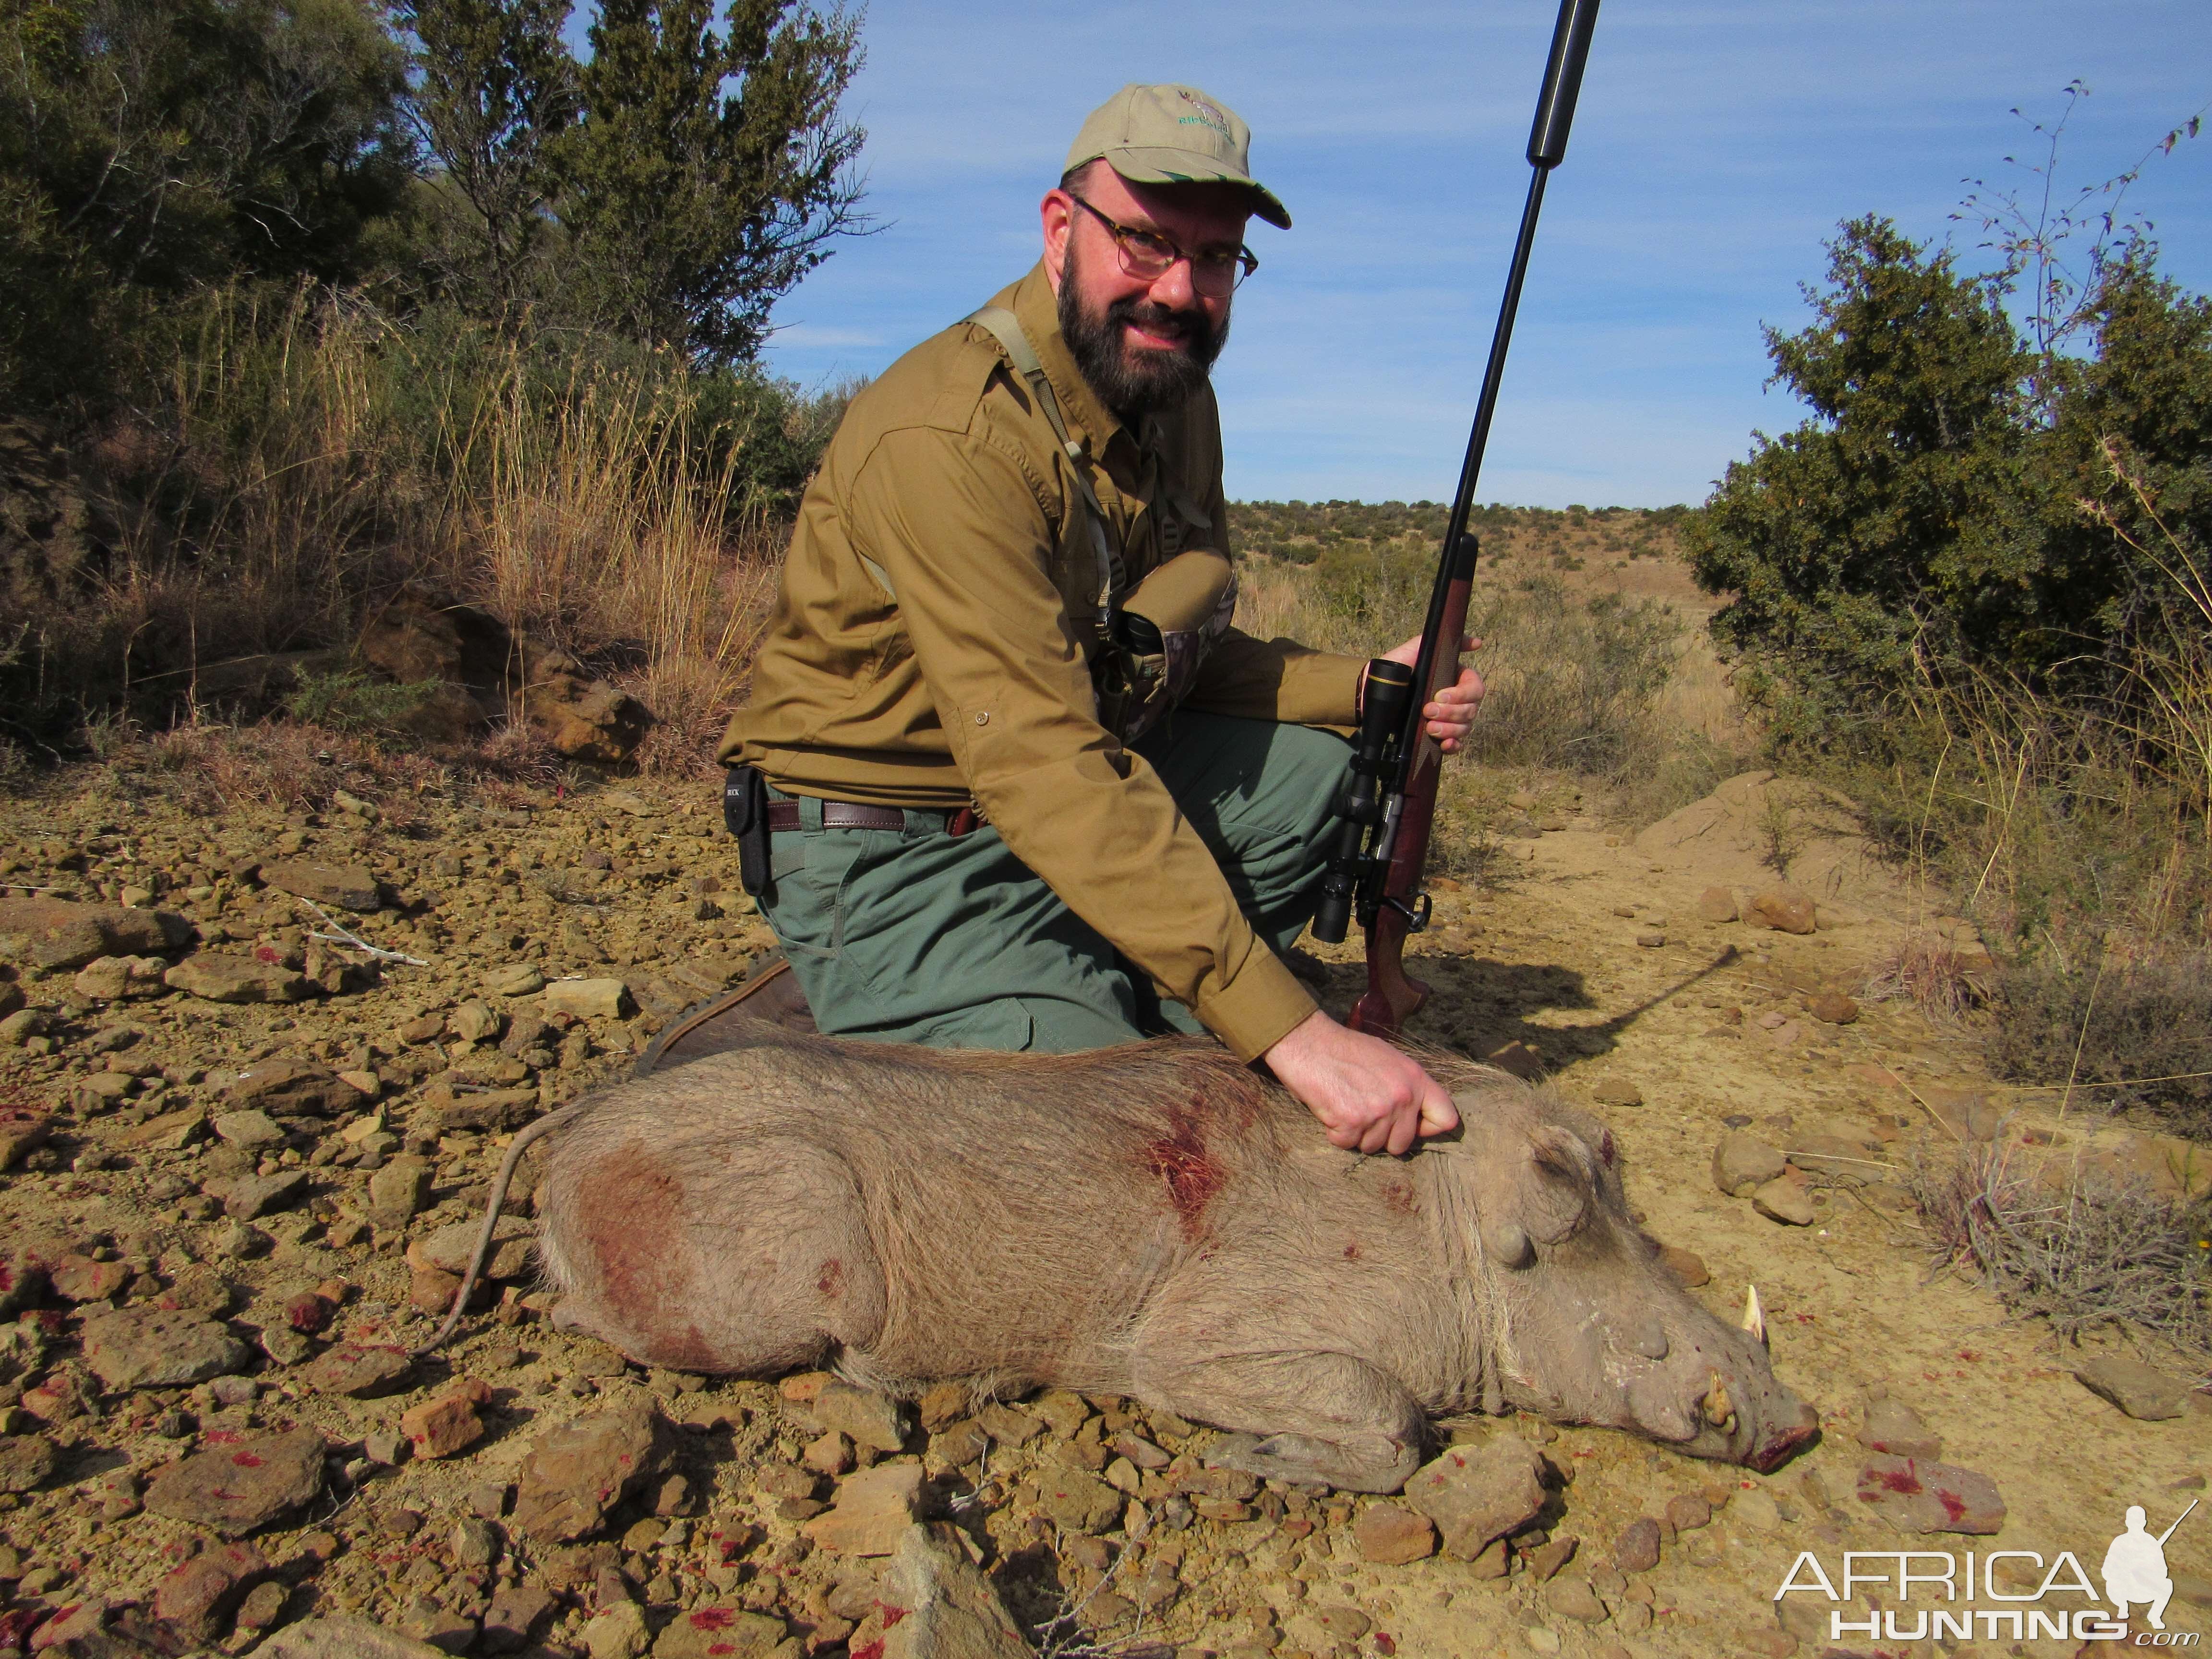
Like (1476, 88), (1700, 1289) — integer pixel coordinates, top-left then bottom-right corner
(721, 265), (1360, 1059)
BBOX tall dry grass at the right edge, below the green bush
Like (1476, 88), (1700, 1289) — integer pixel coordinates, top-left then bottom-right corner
(1838, 465), (2212, 1132)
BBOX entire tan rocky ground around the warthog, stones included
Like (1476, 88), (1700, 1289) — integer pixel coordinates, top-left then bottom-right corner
(0, 774), (2212, 1659)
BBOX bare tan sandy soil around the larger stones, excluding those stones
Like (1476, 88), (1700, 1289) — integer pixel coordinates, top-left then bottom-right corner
(0, 776), (2212, 1659)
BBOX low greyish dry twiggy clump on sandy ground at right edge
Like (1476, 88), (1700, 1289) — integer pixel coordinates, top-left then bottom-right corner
(1913, 1139), (2212, 1354)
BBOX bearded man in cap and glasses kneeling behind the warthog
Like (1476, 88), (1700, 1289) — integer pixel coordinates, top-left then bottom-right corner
(721, 86), (1482, 1153)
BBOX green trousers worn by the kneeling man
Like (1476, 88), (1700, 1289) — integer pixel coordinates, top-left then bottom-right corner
(761, 712), (1349, 1053)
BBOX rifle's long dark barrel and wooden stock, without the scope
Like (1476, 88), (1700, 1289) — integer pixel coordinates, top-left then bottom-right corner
(1338, 0), (1597, 1037)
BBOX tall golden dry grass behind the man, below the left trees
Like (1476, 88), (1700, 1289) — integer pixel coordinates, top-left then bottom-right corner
(13, 292), (781, 770)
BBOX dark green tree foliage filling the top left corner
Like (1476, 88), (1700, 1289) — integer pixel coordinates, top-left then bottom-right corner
(0, 0), (416, 409)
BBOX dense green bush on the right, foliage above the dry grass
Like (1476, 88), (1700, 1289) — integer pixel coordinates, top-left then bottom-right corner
(1688, 219), (2212, 748)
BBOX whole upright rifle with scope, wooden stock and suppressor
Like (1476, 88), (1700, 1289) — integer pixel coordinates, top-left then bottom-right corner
(1314, 0), (1597, 1037)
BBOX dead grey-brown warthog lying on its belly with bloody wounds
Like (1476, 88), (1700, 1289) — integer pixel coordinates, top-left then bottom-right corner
(493, 1026), (1816, 1491)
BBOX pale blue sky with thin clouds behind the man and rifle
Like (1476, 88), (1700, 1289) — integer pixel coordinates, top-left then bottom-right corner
(721, 0), (2212, 506)
